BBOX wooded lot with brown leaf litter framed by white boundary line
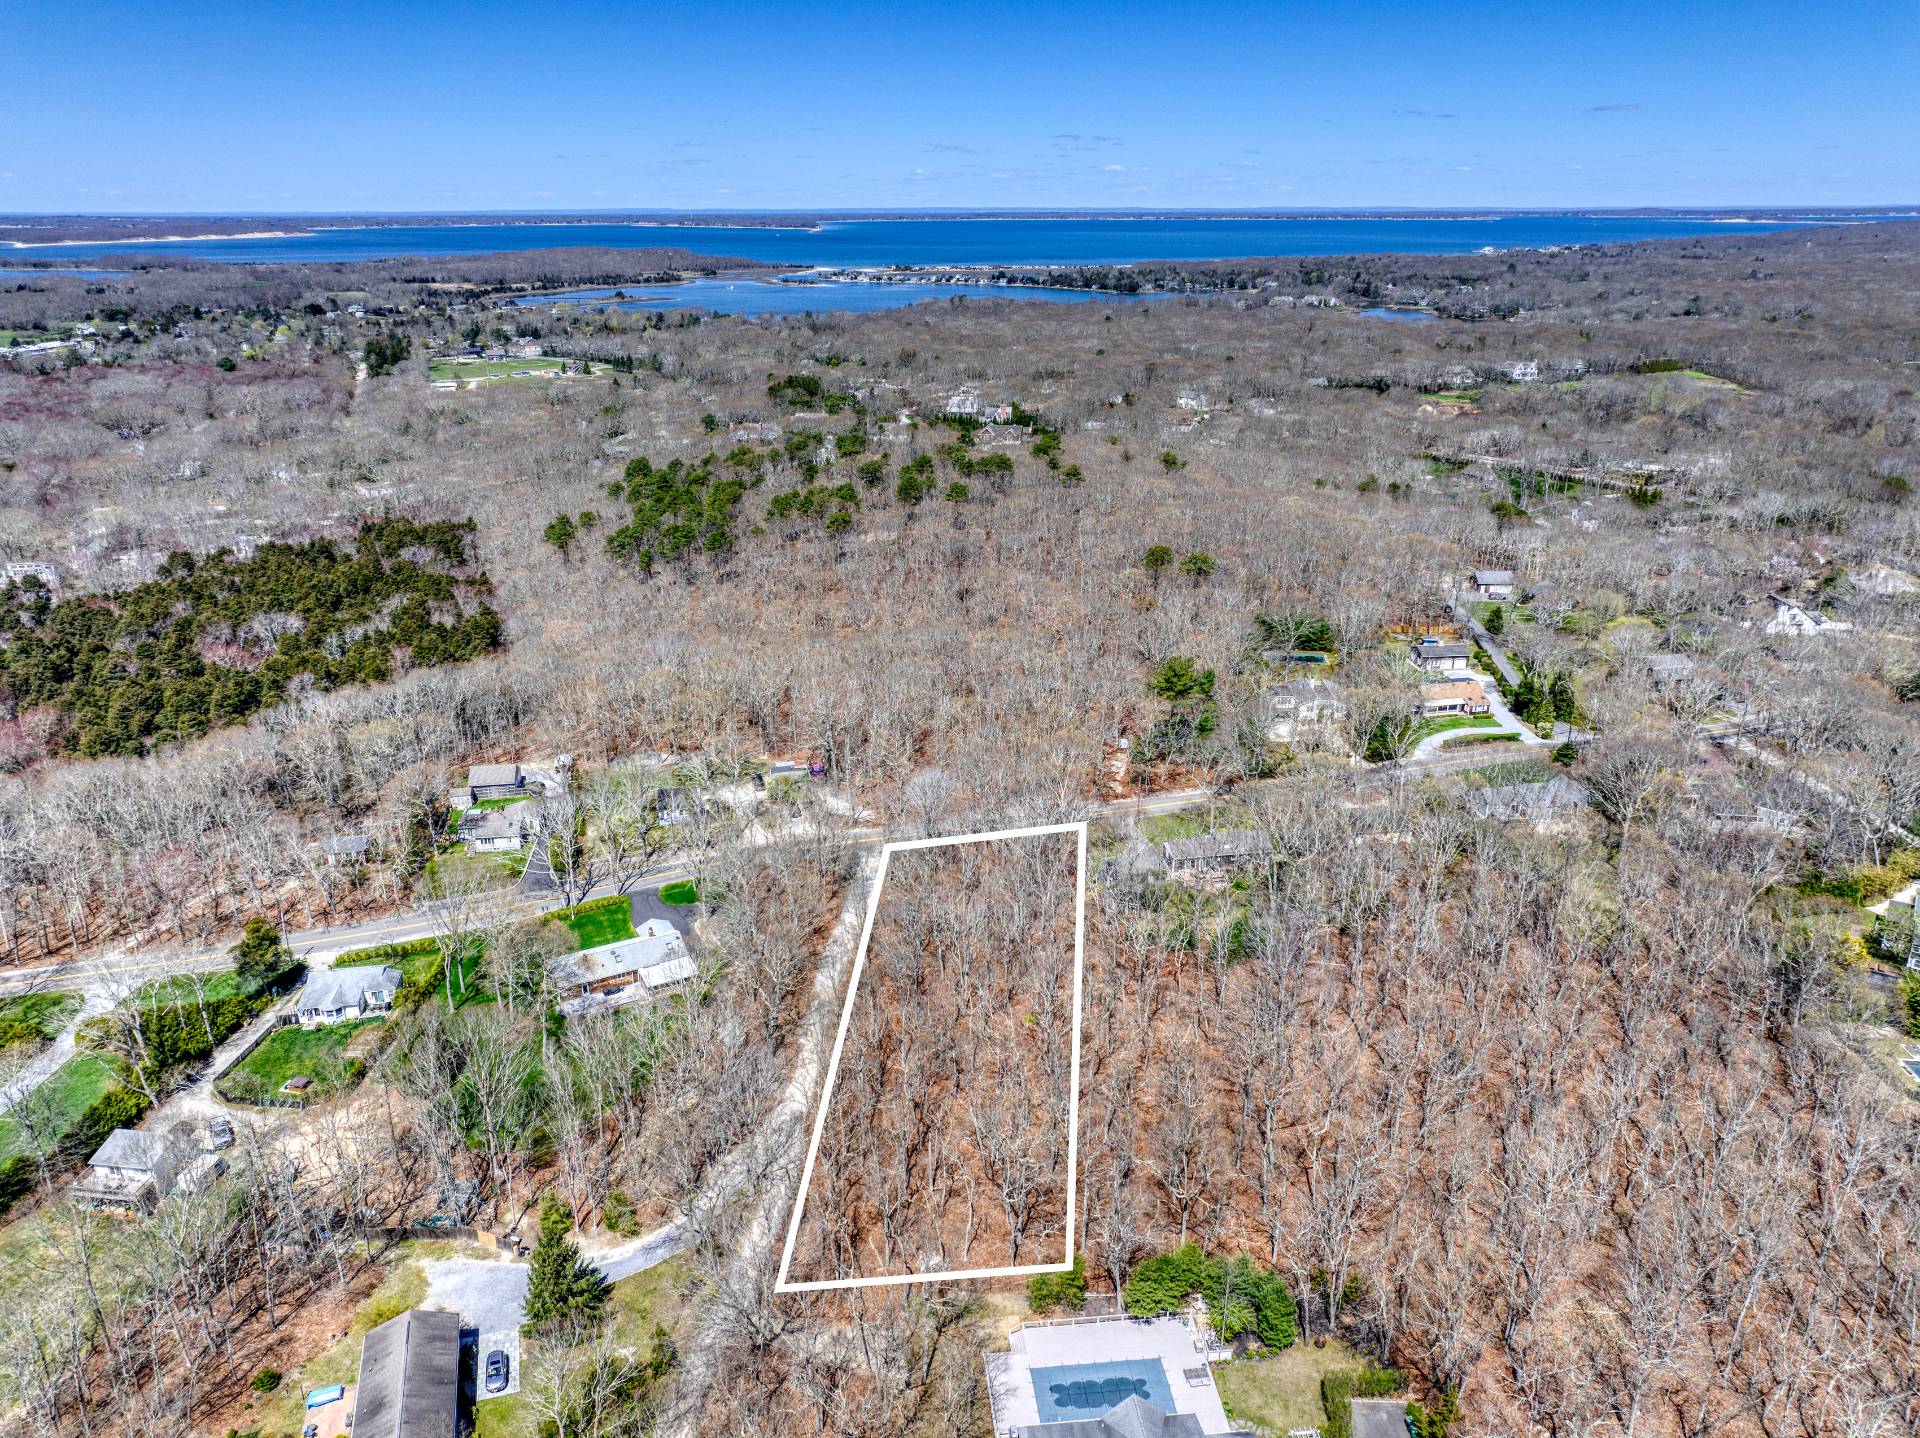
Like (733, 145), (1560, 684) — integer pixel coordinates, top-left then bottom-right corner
(774, 820), (1087, 1294)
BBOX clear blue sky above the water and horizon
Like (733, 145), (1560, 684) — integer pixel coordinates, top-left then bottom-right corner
(0, 0), (1920, 213)
